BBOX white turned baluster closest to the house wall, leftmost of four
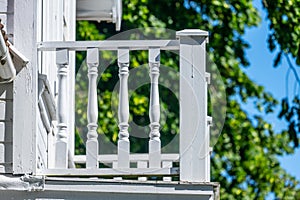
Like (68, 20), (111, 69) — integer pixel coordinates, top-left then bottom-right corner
(55, 49), (69, 169)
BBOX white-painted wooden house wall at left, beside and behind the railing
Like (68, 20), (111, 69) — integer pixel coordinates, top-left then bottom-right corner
(0, 0), (76, 174)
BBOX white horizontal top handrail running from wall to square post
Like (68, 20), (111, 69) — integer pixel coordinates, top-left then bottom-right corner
(38, 40), (179, 51)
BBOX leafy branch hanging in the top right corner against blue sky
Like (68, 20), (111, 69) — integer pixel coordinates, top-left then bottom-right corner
(263, 0), (300, 147)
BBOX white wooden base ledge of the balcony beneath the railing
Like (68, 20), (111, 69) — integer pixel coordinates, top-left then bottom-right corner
(0, 177), (219, 200)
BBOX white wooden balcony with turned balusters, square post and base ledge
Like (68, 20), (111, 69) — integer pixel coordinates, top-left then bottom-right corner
(0, 30), (219, 200)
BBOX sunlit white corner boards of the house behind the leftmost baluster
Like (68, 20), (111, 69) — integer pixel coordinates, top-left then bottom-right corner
(38, 0), (76, 168)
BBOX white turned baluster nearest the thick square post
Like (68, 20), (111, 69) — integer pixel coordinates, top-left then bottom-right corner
(149, 48), (161, 168)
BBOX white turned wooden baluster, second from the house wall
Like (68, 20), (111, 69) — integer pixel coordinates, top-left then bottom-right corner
(86, 48), (99, 168)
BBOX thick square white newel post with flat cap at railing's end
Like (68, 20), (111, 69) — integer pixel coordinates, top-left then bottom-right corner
(176, 29), (210, 182)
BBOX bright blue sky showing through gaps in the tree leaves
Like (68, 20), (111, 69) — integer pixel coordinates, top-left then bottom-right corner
(244, 0), (300, 180)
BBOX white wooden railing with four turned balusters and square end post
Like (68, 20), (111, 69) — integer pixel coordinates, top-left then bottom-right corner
(38, 30), (211, 182)
